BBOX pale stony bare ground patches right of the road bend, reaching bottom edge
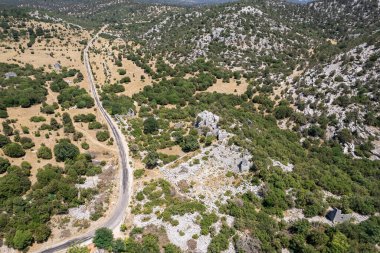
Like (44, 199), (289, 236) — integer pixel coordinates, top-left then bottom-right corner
(127, 136), (259, 252)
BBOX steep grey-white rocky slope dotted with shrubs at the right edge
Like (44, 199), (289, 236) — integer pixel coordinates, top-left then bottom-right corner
(287, 43), (380, 156)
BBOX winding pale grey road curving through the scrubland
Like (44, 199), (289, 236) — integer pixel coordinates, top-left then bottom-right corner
(37, 26), (133, 253)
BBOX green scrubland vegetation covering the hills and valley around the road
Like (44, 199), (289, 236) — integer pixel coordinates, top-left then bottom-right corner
(0, 0), (380, 253)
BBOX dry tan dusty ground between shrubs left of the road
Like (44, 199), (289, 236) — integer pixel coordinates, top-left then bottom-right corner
(0, 18), (119, 250)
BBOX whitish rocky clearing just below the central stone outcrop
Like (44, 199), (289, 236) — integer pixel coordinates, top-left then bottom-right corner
(160, 142), (261, 209)
